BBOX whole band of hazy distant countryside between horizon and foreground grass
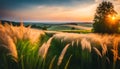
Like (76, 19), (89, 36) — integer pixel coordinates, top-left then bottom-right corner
(1, 21), (92, 31)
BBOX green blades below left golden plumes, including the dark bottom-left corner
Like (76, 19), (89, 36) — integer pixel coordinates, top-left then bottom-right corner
(0, 34), (46, 69)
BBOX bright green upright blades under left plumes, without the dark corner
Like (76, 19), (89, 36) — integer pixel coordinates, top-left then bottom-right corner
(16, 40), (42, 69)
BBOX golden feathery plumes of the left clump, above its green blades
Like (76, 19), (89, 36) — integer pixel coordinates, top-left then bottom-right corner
(0, 23), (45, 58)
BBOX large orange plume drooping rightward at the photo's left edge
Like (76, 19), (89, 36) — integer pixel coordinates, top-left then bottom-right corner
(0, 29), (18, 59)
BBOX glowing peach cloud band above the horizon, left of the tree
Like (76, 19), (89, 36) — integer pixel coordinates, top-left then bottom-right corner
(3, 4), (97, 21)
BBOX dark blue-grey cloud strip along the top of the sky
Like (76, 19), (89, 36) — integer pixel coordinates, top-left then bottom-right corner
(0, 0), (92, 9)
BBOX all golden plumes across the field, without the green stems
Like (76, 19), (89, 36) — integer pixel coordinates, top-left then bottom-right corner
(0, 23), (120, 69)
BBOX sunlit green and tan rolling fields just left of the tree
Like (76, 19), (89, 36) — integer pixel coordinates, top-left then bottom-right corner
(47, 24), (92, 33)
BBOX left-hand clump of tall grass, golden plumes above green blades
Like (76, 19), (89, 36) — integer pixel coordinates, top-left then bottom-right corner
(0, 23), (45, 69)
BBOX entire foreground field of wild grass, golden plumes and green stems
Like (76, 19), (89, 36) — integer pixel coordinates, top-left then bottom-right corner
(0, 23), (120, 69)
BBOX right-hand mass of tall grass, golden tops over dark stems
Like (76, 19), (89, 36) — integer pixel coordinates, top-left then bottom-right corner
(40, 33), (120, 69)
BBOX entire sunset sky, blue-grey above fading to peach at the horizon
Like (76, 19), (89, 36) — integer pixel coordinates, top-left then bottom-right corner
(0, 0), (120, 22)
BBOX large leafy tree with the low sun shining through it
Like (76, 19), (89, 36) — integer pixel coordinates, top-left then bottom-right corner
(93, 1), (119, 34)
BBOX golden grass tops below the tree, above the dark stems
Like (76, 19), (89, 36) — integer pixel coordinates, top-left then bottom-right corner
(53, 33), (120, 62)
